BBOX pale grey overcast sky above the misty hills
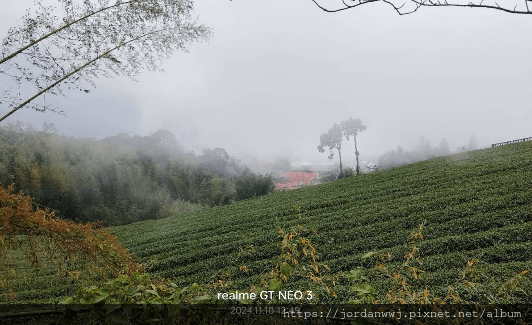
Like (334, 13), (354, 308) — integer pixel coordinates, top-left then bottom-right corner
(0, 0), (532, 165)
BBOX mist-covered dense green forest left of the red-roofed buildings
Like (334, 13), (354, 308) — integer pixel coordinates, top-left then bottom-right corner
(0, 122), (274, 225)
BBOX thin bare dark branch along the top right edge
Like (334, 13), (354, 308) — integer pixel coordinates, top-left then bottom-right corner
(312, 0), (532, 15)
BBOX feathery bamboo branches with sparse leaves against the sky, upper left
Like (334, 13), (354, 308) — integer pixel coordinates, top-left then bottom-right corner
(0, 0), (211, 122)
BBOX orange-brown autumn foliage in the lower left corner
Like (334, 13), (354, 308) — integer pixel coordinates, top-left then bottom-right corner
(0, 184), (140, 298)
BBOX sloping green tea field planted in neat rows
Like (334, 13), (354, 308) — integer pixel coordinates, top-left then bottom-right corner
(112, 142), (532, 303)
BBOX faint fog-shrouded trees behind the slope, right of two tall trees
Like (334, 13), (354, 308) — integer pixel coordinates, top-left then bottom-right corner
(378, 137), (477, 169)
